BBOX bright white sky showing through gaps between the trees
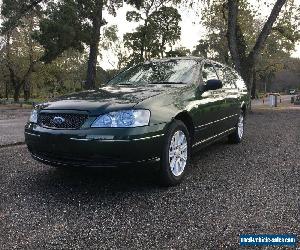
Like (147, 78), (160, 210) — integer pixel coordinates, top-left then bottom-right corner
(99, 0), (300, 69)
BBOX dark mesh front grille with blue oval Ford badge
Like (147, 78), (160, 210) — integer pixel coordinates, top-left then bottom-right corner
(38, 113), (88, 129)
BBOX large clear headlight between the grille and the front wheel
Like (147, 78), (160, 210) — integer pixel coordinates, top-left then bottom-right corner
(91, 109), (150, 128)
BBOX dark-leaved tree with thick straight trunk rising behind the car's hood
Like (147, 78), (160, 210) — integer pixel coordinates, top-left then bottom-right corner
(30, 0), (123, 89)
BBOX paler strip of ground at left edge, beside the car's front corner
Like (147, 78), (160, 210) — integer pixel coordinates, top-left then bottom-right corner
(0, 107), (30, 147)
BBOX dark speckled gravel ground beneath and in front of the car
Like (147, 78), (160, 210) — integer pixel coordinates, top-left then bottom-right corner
(0, 110), (300, 249)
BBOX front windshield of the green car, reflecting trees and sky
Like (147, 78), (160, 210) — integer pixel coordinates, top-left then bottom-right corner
(108, 60), (197, 85)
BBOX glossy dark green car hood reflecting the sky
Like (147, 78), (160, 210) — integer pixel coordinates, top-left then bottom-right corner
(39, 84), (178, 112)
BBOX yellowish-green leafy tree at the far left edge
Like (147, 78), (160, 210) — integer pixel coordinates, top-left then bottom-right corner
(1, 0), (46, 101)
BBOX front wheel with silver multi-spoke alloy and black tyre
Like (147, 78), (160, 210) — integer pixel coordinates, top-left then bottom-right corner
(160, 120), (191, 186)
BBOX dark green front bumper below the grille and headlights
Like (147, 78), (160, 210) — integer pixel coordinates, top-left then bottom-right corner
(25, 123), (166, 167)
